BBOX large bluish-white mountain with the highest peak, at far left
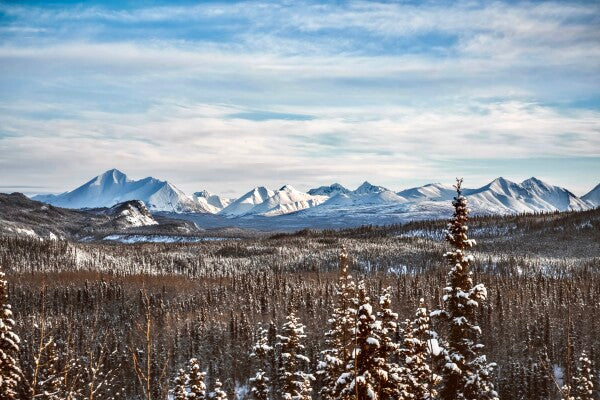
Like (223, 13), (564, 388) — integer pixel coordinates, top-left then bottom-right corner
(33, 169), (206, 212)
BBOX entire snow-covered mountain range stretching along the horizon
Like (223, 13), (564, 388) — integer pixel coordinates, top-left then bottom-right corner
(33, 169), (600, 223)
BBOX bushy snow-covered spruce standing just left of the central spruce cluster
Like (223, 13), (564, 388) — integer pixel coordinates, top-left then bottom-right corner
(277, 311), (314, 400)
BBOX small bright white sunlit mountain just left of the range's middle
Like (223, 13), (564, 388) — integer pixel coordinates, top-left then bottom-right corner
(246, 185), (328, 216)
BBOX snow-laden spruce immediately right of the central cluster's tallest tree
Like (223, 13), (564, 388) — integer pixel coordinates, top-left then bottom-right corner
(336, 281), (381, 400)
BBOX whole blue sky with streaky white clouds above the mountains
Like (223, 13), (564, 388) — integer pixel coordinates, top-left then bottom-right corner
(0, 0), (600, 196)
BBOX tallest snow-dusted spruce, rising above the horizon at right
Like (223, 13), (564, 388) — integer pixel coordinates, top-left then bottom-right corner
(431, 179), (498, 400)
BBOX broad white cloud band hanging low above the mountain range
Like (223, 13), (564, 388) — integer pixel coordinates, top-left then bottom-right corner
(0, 102), (600, 194)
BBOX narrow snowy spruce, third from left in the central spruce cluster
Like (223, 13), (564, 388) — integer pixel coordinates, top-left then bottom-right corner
(375, 288), (404, 399)
